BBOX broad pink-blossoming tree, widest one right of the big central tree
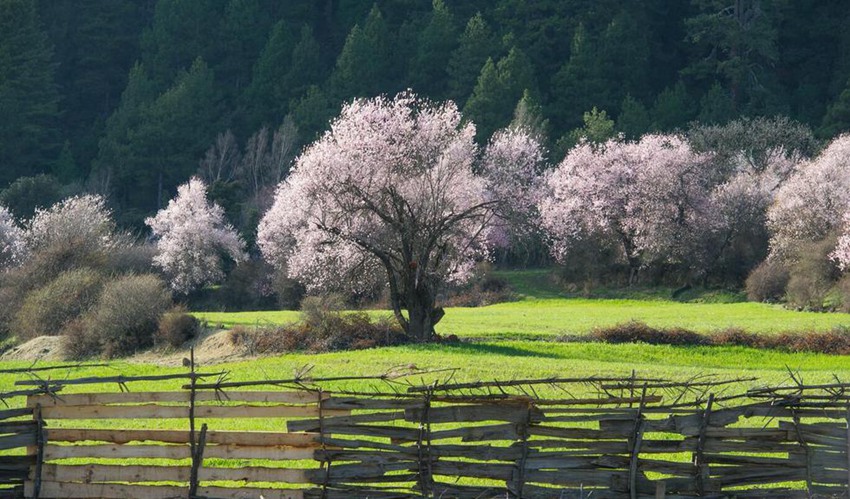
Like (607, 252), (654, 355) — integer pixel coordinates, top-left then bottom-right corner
(539, 135), (714, 278)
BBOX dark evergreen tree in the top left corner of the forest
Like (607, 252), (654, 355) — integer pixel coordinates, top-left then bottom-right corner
(0, 0), (62, 186)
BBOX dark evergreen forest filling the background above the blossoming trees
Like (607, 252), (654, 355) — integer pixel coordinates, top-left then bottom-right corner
(0, 0), (850, 229)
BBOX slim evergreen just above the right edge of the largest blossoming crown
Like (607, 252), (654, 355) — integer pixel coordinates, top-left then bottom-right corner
(447, 12), (498, 102)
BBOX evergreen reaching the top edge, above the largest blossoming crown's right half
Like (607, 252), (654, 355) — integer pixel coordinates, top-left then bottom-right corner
(409, 0), (457, 100)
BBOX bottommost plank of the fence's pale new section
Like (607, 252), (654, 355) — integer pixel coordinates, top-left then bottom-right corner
(24, 481), (304, 499)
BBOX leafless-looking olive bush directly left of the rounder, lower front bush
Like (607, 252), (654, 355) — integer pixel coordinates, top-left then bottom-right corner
(14, 269), (103, 340)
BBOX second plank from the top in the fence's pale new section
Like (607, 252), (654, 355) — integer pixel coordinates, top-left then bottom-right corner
(42, 404), (351, 419)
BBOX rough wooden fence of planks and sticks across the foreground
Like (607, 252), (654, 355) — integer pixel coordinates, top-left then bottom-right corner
(0, 366), (850, 499)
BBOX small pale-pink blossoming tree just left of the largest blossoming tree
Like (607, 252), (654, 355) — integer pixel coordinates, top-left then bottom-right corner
(145, 177), (247, 293)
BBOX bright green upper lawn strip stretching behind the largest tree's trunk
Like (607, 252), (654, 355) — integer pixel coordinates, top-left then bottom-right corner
(196, 271), (850, 341)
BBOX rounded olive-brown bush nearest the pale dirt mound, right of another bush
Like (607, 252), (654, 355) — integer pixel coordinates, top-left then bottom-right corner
(78, 274), (171, 358)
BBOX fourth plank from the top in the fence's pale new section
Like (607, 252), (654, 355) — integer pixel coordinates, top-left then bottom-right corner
(44, 444), (315, 461)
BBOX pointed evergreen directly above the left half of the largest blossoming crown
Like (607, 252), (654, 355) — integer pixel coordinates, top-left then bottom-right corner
(330, 5), (390, 100)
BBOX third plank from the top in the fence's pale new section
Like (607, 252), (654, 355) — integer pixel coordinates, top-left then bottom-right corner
(45, 428), (319, 448)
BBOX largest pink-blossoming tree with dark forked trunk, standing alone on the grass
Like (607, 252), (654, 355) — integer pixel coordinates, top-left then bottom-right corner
(258, 93), (540, 341)
